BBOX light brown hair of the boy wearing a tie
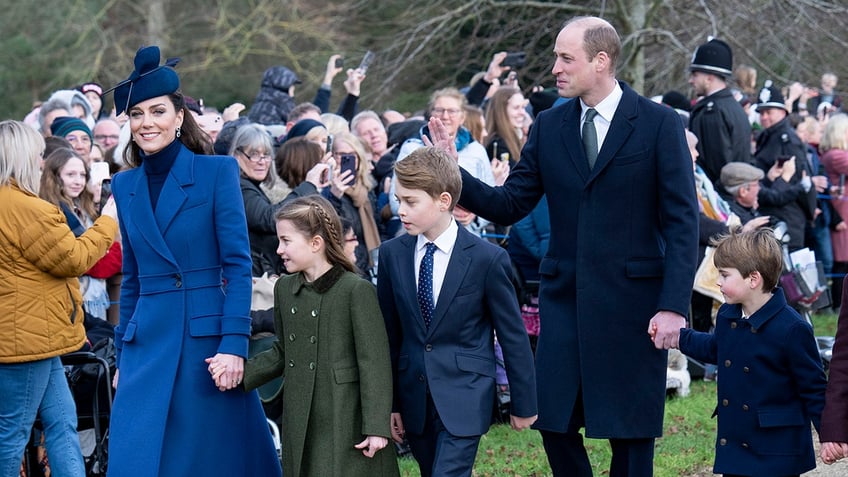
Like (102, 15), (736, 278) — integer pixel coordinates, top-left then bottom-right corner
(394, 146), (462, 211)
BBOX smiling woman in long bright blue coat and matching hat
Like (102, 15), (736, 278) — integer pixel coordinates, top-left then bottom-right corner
(104, 46), (282, 477)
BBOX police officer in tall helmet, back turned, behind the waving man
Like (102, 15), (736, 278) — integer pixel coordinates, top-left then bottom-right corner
(689, 39), (751, 183)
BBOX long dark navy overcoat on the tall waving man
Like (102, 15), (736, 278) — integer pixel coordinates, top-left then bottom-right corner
(459, 83), (698, 438)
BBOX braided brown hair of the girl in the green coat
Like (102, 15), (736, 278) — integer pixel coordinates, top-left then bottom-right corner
(275, 194), (356, 272)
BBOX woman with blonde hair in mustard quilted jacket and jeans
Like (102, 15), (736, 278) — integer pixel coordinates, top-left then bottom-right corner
(0, 121), (118, 477)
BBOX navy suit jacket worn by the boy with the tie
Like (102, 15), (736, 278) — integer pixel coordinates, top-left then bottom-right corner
(377, 227), (537, 436)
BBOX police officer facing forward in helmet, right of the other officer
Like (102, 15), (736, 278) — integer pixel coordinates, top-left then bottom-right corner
(754, 80), (816, 251)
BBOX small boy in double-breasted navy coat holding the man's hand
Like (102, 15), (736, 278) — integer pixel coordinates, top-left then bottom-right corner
(660, 229), (827, 477)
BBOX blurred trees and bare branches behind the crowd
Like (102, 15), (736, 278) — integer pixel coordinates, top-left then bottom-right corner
(0, 0), (848, 119)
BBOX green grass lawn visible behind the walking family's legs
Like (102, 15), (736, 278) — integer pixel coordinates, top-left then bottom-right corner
(399, 313), (836, 477)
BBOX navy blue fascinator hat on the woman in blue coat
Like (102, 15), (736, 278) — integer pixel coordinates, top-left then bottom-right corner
(104, 46), (180, 114)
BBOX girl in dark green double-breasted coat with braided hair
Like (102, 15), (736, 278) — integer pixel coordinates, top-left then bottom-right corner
(229, 195), (398, 477)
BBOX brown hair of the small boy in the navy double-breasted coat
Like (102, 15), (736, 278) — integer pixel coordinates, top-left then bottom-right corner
(713, 228), (783, 292)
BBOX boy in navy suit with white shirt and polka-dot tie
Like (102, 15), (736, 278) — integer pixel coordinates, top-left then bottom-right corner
(377, 147), (536, 477)
